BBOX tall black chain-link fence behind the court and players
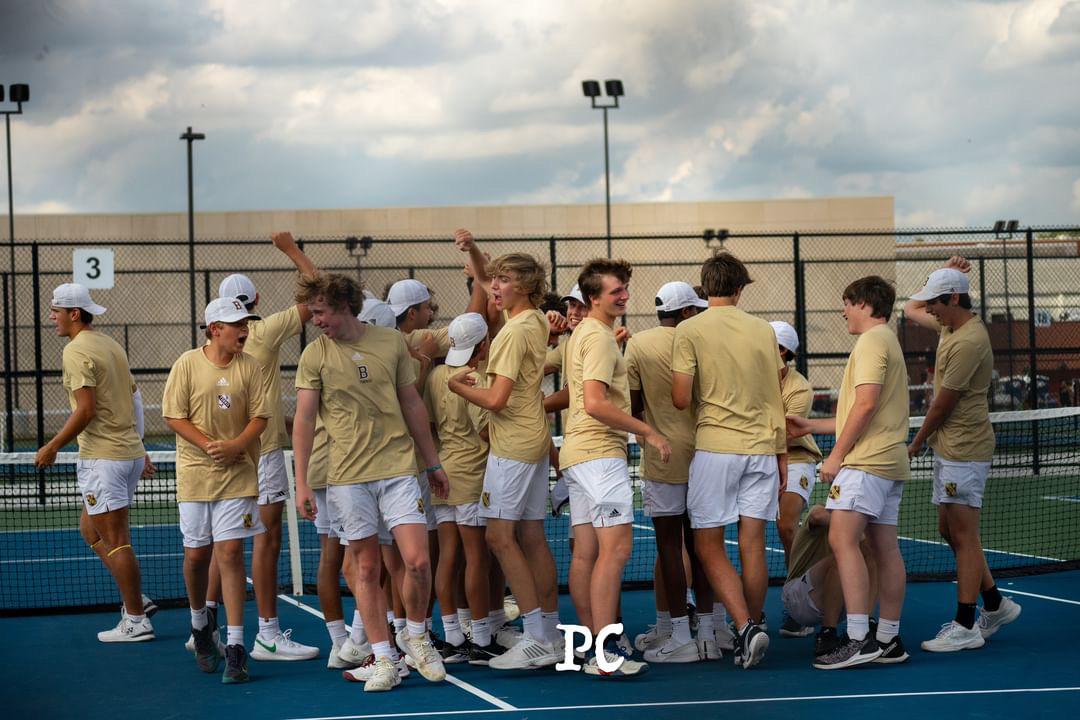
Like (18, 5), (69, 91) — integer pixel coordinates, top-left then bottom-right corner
(0, 228), (1080, 451)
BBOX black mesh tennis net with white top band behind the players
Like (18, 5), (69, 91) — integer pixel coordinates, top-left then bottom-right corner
(0, 408), (1080, 614)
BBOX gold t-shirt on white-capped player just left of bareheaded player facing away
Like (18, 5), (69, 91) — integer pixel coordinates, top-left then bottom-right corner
(626, 325), (694, 484)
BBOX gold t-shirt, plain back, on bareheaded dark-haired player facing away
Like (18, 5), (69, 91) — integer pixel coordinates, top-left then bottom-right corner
(672, 305), (787, 454)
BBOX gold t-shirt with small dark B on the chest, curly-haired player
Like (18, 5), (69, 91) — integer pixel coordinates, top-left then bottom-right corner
(296, 325), (416, 485)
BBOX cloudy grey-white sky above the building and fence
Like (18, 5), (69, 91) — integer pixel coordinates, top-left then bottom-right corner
(0, 0), (1080, 227)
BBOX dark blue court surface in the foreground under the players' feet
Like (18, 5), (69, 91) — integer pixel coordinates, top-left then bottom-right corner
(0, 571), (1080, 720)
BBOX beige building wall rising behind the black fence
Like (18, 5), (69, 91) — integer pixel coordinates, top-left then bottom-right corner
(0, 196), (895, 442)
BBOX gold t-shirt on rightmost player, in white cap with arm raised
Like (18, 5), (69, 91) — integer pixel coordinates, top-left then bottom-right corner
(930, 316), (994, 462)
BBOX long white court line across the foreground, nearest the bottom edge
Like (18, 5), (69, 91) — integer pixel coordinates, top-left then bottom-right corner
(285, 687), (1080, 720)
